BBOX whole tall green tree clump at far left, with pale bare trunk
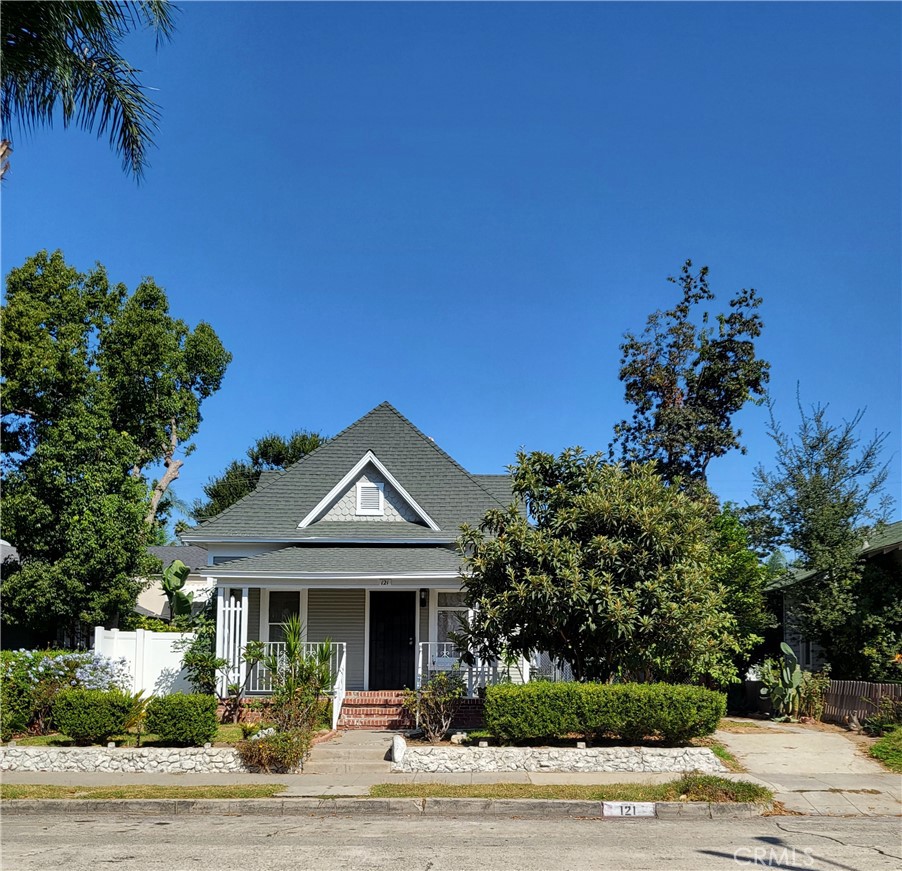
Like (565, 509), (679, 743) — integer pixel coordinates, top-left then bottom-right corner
(0, 252), (231, 631)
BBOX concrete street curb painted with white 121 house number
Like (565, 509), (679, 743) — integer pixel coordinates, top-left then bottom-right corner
(0, 798), (772, 820)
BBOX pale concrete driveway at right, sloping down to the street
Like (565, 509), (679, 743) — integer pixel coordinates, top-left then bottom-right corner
(715, 720), (902, 815)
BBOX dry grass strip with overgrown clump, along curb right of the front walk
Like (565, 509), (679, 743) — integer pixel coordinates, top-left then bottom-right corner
(370, 774), (774, 803)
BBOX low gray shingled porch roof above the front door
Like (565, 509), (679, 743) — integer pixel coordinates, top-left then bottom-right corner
(204, 545), (461, 577)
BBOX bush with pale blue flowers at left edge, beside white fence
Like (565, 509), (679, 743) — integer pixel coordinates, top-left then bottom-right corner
(0, 650), (131, 741)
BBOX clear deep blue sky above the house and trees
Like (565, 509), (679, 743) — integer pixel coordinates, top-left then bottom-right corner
(2, 2), (902, 518)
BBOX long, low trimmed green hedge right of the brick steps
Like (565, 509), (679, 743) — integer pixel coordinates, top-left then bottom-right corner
(485, 681), (727, 743)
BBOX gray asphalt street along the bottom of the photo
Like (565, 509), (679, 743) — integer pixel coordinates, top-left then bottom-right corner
(2, 814), (902, 871)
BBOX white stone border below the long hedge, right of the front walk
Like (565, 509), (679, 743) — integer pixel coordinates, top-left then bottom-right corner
(392, 736), (727, 774)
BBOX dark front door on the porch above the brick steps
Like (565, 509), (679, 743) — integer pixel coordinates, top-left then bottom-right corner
(370, 590), (417, 690)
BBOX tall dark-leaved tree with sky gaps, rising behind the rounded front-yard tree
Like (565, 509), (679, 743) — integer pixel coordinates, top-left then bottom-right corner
(610, 260), (770, 485)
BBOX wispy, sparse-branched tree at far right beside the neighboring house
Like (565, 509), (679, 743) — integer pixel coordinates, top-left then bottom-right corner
(747, 402), (902, 679)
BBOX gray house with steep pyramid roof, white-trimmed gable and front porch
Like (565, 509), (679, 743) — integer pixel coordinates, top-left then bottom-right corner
(182, 403), (528, 720)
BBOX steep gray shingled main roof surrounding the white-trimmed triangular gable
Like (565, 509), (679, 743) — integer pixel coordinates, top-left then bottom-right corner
(182, 402), (509, 542)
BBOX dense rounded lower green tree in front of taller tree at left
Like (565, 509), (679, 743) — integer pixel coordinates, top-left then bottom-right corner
(2, 406), (159, 643)
